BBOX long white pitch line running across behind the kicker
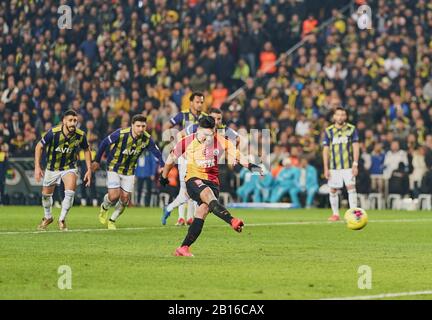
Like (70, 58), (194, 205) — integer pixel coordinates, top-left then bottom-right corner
(0, 218), (432, 235)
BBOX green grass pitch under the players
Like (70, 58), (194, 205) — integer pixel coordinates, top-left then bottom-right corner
(0, 206), (432, 299)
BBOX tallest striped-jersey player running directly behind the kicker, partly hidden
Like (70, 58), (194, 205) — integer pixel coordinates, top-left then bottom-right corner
(162, 92), (207, 226)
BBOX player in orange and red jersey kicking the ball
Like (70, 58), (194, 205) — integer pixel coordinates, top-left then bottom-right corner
(160, 116), (262, 256)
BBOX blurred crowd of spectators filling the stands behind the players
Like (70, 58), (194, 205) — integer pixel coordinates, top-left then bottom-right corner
(0, 0), (432, 204)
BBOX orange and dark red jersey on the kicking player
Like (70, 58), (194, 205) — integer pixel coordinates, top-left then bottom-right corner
(172, 133), (240, 184)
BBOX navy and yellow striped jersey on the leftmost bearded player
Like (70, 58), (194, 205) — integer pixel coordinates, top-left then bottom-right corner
(40, 125), (89, 171)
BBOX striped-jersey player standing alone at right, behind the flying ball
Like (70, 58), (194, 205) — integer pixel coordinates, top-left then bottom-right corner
(323, 107), (360, 221)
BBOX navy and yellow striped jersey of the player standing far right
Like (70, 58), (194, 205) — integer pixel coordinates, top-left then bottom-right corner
(323, 123), (359, 170)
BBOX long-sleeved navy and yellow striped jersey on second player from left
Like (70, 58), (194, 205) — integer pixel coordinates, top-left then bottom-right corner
(95, 127), (164, 175)
